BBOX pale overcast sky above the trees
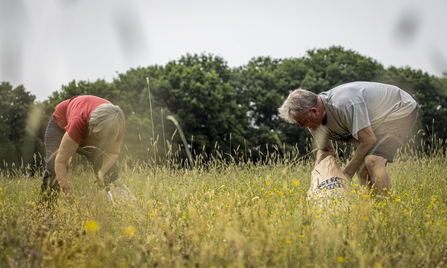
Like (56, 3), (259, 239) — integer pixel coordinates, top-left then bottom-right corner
(0, 0), (447, 101)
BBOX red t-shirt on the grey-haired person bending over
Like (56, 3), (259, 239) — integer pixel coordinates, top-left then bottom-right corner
(53, 95), (126, 145)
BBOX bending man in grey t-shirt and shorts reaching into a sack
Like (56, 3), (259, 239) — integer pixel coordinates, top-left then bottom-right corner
(278, 82), (418, 193)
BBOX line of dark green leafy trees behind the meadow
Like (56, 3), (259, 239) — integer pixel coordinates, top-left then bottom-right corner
(0, 46), (447, 171)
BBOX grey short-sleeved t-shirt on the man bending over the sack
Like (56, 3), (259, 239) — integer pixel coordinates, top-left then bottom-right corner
(309, 82), (417, 148)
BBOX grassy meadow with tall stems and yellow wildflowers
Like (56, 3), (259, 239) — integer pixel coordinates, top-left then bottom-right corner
(0, 144), (447, 267)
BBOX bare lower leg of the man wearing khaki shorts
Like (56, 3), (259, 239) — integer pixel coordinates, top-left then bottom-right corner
(365, 155), (391, 195)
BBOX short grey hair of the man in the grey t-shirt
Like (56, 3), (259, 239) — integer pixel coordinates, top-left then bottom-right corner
(278, 88), (318, 123)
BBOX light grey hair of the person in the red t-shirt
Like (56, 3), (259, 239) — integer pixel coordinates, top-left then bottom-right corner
(89, 103), (124, 142)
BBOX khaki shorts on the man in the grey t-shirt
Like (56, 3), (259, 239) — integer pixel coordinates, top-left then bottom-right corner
(366, 108), (418, 163)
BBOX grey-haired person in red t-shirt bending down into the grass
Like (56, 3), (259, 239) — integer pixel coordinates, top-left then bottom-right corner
(41, 95), (125, 200)
